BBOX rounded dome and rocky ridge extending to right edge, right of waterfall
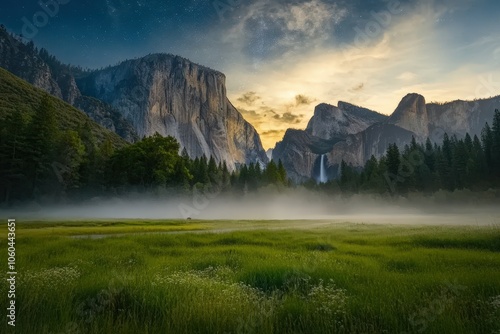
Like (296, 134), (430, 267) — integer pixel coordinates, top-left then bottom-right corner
(328, 94), (500, 170)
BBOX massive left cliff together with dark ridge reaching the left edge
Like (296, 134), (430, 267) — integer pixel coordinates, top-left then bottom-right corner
(0, 28), (268, 169)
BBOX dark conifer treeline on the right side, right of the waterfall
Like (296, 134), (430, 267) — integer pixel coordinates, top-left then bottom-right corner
(330, 110), (500, 195)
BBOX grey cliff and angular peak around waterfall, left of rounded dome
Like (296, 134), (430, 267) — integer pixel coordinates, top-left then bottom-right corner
(273, 102), (388, 183)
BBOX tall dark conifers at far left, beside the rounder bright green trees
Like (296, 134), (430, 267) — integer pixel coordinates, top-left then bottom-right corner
(0, 96), (113, 203)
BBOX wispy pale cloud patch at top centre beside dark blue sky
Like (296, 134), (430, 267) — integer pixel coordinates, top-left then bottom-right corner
(223, 0), (347, 61)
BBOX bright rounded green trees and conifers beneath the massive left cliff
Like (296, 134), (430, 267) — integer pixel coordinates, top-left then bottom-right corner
(106, 134), (288, 193)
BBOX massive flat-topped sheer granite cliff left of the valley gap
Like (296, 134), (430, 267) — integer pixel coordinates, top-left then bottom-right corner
(78, 54), (268, 169)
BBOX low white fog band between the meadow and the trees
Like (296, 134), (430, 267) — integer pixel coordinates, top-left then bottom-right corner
(0, 191), (500, 225)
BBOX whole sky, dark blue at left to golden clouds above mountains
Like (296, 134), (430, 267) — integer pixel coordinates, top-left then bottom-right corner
(0, 0), (500, 149)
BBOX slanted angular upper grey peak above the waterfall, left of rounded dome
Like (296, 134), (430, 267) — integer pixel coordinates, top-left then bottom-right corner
(306, 102), (387, 140)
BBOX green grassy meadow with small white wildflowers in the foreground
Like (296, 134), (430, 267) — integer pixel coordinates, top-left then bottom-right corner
(0, 220), (500, 334)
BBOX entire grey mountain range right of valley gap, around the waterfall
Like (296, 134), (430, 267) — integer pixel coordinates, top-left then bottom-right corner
(273, 94), (500, 182)
